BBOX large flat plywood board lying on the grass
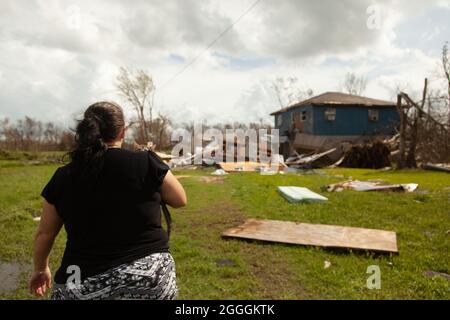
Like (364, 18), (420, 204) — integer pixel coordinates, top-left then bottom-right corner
(222, 219), (398, 252)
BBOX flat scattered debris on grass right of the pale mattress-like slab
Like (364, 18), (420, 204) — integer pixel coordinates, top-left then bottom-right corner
(326, 180), (418, 192)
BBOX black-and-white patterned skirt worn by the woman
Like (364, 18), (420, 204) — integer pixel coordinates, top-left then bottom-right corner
(51, 252), (178, 300)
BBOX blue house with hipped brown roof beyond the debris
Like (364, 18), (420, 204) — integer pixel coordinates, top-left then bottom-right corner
(271, 92), (400, 156)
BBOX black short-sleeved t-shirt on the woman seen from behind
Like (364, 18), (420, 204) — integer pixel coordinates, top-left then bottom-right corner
(41, 148), (169, 283)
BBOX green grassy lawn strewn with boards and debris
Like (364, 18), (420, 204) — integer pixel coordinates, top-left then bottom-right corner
(0, 160), (450, 299)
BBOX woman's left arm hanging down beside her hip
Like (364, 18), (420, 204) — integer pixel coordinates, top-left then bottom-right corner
(29, 200), (63, 296)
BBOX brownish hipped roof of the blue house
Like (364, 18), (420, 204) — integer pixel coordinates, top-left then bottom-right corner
(270, 92), (396, 116)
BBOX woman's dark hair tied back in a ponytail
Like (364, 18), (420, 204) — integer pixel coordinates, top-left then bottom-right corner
(69, 101), (125, 177)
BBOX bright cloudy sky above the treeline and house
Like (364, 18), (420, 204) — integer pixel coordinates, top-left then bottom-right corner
(0, 0), (450, 124)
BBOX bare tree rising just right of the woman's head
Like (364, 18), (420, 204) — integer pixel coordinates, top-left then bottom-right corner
(116, 67), (155, 143)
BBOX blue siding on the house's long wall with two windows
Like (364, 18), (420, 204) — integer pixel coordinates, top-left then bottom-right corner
(313, 106), (400, 136)
